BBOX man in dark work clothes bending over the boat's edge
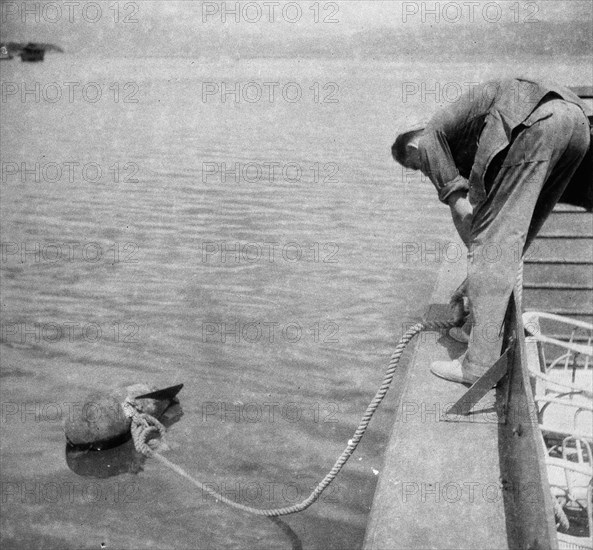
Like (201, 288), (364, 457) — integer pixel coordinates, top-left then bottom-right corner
(392, 79), (593, 383)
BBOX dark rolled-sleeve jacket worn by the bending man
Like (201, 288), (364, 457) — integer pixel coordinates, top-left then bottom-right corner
(419, 79), (593, 210)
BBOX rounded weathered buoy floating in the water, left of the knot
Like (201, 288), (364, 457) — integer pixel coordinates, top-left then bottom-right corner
(64, 393), (130, 449)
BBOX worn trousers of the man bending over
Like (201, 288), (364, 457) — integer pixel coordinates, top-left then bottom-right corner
(463, 99), (590, 374)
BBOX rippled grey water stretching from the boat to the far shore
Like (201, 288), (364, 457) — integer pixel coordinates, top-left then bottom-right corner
(0, 55), (587, 549)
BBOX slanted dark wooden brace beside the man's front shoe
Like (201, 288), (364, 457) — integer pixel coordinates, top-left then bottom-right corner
(442, 339), (515, 423)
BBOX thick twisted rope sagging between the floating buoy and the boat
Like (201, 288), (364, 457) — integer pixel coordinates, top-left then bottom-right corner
(123, 321), (463, 517)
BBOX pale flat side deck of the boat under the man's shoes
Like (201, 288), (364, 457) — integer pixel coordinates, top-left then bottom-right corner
(364, 249), (507, 550)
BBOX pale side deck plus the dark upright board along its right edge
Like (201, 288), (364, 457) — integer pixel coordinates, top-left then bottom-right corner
(364, 232), (558, 550)
